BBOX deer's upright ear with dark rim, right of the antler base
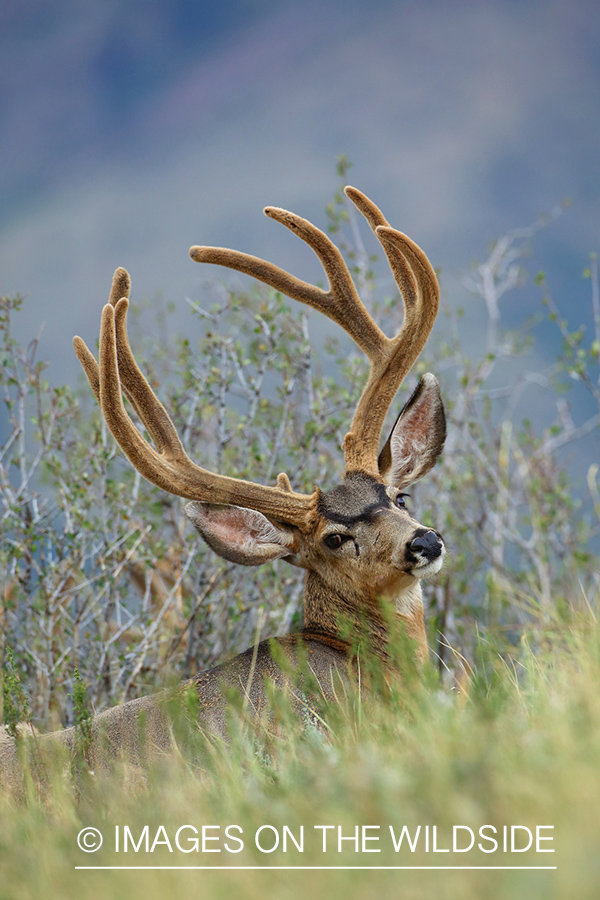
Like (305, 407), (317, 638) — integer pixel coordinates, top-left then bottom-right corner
(378, 373), (446, 489)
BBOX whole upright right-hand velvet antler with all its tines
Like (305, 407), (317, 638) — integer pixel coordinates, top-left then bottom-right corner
(190, 187), (439, 476)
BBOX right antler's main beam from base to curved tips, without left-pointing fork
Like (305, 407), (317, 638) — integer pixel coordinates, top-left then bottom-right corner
(344, 187), (439, 475)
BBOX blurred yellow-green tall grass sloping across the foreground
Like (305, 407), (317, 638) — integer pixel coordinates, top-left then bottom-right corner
(0, 615), (600, 900)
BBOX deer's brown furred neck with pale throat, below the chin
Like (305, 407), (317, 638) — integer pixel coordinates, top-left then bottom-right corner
(304, 571), (428, 663)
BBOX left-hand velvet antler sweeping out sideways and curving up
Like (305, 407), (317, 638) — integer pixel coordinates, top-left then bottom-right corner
(74, 276), (318, 531)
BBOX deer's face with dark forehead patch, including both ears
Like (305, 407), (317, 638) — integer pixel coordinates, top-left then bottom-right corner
(186, 375), (446, 601)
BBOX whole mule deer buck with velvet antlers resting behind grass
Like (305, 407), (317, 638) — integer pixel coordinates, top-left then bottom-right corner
(0, 187), (446, 788)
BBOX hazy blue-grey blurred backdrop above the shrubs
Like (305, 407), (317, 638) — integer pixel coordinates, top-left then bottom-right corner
(0, 0), (600, 404)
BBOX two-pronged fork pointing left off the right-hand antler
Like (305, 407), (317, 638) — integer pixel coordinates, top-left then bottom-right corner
(190, 206), (387, 359)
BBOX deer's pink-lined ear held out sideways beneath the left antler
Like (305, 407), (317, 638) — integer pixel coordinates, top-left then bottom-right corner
(185, 501), (298, 566)
